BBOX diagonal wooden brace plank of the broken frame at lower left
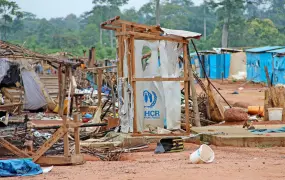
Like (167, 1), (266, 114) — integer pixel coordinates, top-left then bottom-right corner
(33, 127), (67, 162)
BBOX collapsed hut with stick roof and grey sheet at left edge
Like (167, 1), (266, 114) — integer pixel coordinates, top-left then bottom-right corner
(0, 41), (79, 110)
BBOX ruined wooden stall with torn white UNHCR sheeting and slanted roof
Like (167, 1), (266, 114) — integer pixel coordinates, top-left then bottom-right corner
(101, 17), (201, 133)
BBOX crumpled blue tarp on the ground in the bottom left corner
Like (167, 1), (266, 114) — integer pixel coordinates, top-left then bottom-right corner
(0, 159), (43, 177)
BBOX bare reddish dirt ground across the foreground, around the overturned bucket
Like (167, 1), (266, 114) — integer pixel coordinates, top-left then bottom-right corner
(8, 144), (285, 180)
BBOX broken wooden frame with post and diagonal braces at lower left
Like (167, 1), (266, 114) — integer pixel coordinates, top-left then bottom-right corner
(0, 63), (85, 165)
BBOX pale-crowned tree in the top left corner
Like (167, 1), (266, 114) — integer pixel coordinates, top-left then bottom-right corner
(0, 0), (23, 40)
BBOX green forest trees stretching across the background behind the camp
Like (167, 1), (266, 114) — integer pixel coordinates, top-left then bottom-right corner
(0, 0), (285, 60)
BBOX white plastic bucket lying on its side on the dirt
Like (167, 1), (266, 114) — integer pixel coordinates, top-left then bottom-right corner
(190, 144), (215, 164)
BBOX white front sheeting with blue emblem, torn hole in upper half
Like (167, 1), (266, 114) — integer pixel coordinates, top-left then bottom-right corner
(135, 40), (182, 131)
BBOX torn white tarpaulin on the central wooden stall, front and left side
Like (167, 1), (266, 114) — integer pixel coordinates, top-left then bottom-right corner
(118, 40), (182, 133)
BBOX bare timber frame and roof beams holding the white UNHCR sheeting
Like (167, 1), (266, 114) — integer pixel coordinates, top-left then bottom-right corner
(101, 16), (201, 134)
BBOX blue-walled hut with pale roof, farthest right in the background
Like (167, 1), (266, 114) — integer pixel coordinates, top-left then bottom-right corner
(246, 46), (283, 83)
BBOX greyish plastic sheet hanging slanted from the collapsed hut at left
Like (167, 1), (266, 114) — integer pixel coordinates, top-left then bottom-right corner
(21, 69), (47, 110)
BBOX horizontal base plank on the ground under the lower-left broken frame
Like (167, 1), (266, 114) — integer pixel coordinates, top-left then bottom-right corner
(36, 154), (85, 166)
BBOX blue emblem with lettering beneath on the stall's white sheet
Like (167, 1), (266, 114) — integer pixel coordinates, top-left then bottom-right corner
(143, 90), (160, 119)
